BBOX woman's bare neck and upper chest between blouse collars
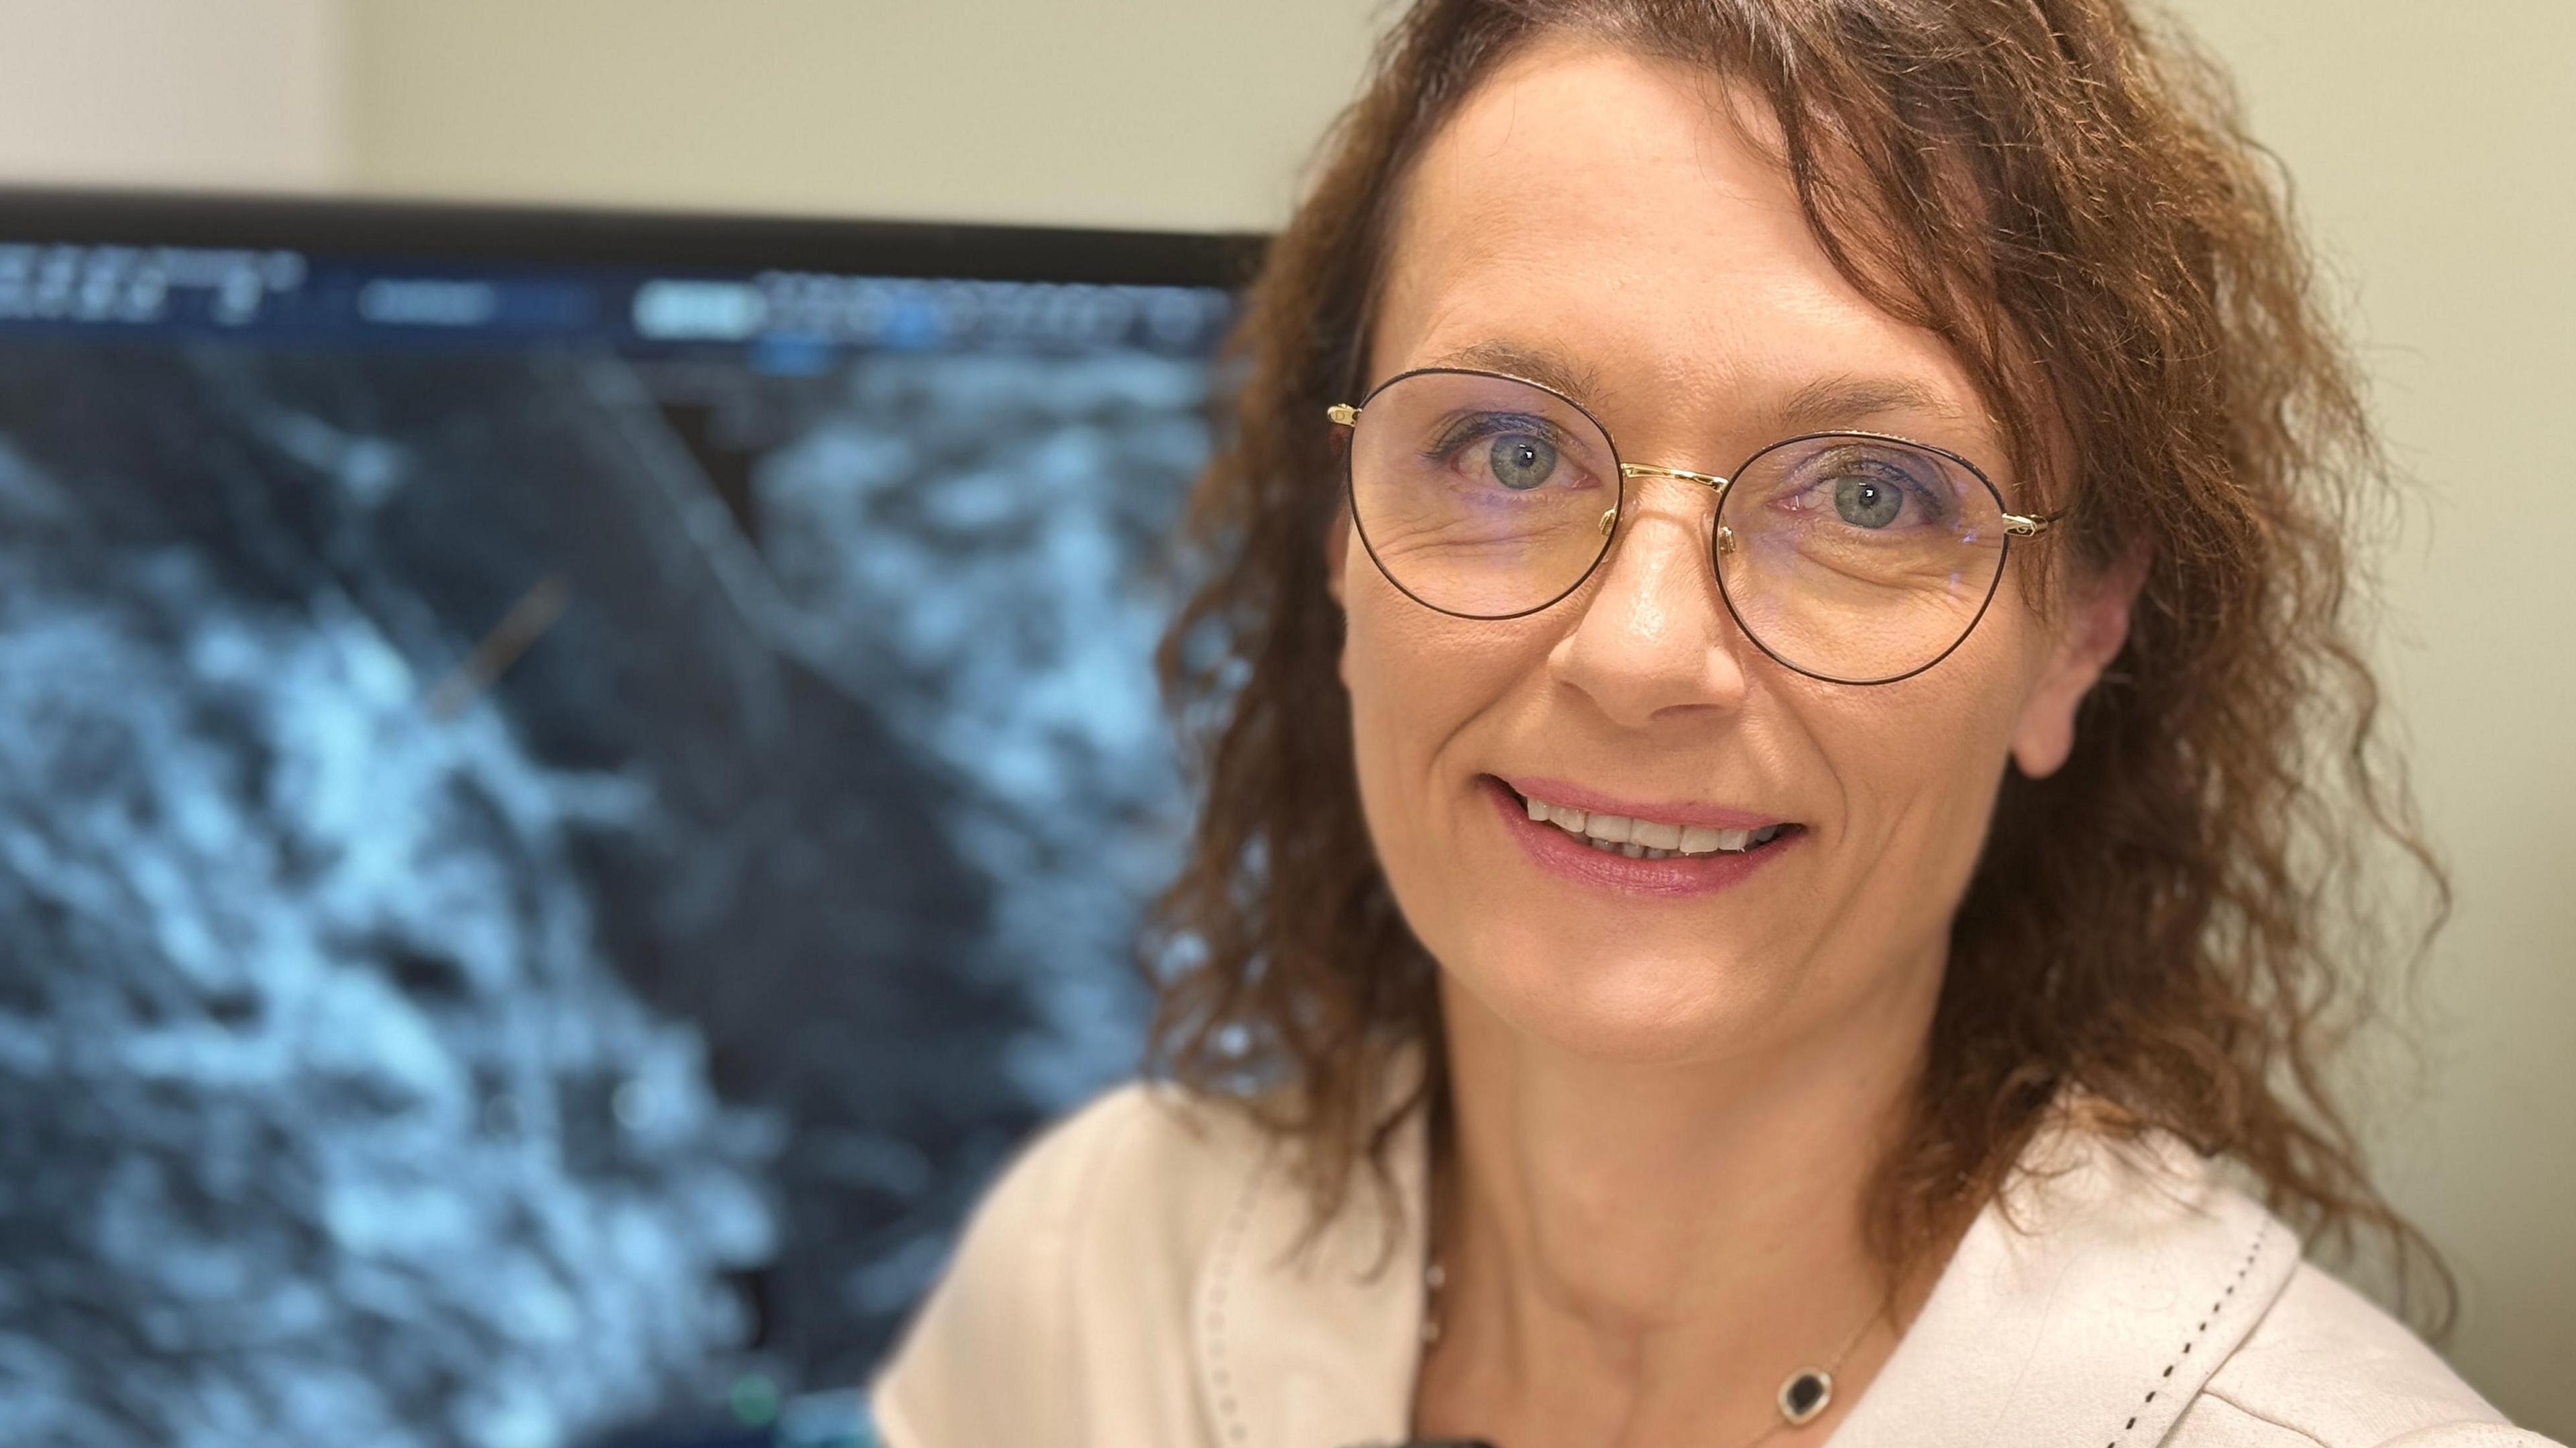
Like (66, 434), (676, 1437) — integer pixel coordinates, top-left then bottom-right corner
(1425, 961), (1940, 1443)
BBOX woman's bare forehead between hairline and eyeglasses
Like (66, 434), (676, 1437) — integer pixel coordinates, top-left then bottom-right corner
(1371, 39), (1991, 453)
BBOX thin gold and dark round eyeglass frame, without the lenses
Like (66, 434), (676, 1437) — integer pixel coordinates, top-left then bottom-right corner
(1324, 366), (2066, 688)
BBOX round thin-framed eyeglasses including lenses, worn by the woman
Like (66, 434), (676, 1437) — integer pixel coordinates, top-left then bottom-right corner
(1329, 368), (2055, 683)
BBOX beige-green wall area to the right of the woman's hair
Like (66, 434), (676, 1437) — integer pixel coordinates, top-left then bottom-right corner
(2153, 0), (2576, 1440)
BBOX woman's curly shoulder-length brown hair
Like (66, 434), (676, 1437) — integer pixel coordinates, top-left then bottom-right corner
(1151, 0), (2455, 1332)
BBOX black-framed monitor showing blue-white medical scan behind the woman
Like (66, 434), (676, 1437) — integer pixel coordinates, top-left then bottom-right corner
(0, 196), (1249, 1448)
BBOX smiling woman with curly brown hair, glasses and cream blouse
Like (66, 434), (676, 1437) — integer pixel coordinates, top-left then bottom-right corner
(876, 0), (2535, 1448)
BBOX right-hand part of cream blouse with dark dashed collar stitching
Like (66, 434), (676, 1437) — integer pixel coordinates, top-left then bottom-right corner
(1831, 1113), (2548, 1448)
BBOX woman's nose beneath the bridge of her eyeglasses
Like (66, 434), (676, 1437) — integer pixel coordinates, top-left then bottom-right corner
(1548, 474), (1752, 726)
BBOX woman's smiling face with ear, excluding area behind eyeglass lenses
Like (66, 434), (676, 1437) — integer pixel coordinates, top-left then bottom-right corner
(1334, 41), (2125, 1062)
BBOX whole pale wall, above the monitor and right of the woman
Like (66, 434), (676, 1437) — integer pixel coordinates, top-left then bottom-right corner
(0, 0), (2576, 1440)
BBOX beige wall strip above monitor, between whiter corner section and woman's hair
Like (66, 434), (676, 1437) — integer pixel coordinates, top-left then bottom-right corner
(350, 0), (1368, 227)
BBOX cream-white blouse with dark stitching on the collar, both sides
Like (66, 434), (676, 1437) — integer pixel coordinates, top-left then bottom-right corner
(873, 1084), (2548, 1448)
